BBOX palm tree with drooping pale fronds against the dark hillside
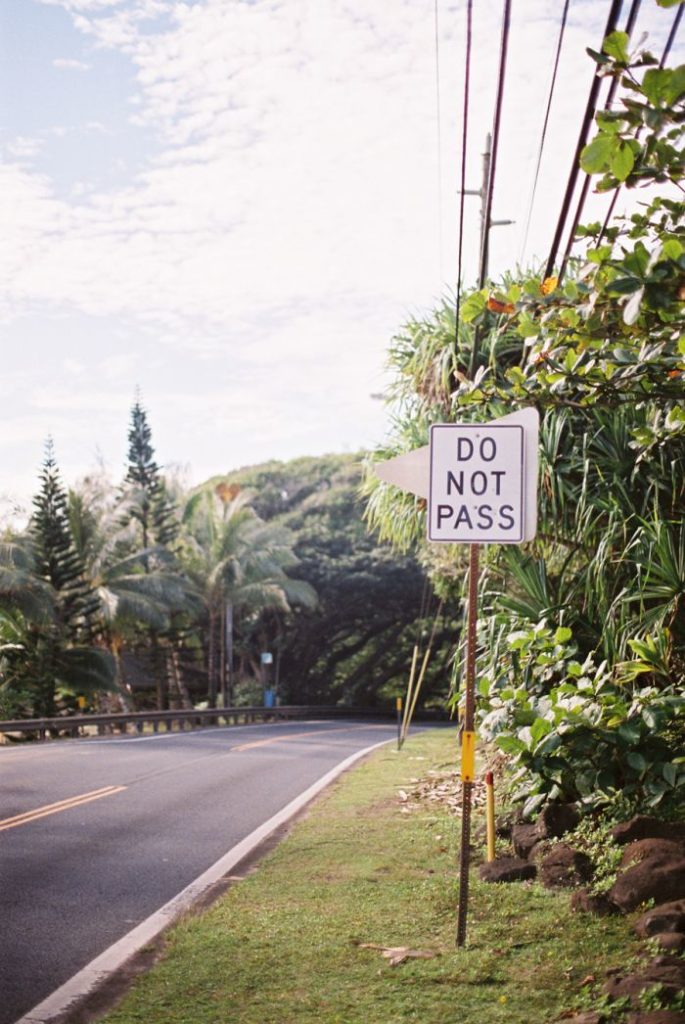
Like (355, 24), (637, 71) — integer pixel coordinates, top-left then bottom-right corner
(181, 485), (316, 708)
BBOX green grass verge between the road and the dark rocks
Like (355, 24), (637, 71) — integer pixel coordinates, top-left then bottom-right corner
(105, 730), (637, 1024)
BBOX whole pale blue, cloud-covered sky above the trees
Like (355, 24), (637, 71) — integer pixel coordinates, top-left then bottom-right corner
(0, 0), (682, 521)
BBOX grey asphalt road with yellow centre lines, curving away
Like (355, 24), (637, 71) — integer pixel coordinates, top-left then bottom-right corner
(0, 720), (395, 1024)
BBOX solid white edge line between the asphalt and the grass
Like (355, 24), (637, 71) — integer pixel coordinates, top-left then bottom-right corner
(14, 739), (392, 1024)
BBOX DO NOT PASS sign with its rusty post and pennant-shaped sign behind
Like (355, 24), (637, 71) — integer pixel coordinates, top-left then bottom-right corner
(377, 409), (540, 946)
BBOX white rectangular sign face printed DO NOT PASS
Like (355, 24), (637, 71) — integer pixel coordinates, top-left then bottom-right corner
(428, 423), (524, 544)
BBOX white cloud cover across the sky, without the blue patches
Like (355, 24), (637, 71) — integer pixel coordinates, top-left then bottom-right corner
(0, 0), (671, 499)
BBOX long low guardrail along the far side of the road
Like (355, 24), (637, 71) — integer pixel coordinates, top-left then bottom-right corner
(0, 705), (447, 739)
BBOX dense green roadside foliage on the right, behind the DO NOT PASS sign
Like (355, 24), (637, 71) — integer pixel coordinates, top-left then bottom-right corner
(367, 33), (685, 812)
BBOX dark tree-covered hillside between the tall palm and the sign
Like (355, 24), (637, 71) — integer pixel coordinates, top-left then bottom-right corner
(202, 455), (458, 707)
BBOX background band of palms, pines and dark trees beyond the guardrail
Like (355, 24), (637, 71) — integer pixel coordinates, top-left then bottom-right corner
(0, 419), (438, 718)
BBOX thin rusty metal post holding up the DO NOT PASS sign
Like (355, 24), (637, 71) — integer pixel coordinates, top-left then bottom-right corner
(457, 544), (480, 946)
